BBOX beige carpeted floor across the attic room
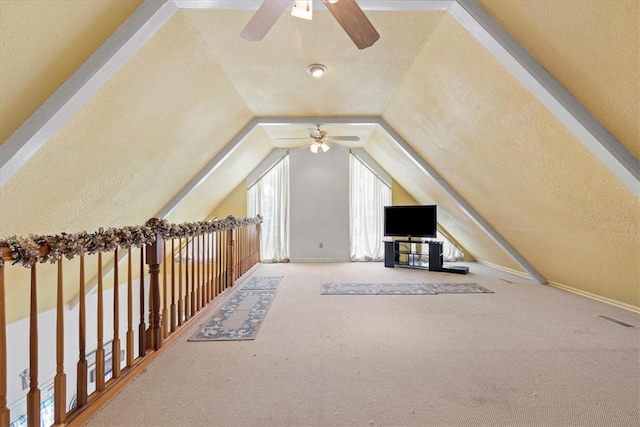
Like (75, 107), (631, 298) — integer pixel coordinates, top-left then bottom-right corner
(87, 263), (640, 427)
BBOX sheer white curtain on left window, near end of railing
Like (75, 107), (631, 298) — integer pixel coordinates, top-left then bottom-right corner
(247, 155), (289, 262)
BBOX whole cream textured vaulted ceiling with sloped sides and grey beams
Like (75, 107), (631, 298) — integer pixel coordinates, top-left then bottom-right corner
(0, 0), (640, 314)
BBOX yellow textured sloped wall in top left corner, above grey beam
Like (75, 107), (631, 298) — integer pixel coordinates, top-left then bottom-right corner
(0, 0), (142, 144)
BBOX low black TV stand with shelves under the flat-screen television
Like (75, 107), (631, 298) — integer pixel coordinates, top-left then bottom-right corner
(384, 238), (469, 274)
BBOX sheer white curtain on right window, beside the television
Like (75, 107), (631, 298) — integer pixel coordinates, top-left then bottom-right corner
(349, 154), (391, 261)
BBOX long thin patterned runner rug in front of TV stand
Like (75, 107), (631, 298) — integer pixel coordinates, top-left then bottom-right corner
(321, 283), (493, 295)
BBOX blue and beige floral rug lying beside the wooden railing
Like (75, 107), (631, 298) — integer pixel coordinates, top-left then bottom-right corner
(189, 290), (276, 341)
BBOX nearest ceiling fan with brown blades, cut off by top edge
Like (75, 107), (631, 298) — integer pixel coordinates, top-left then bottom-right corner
(240, 0), (380, 49)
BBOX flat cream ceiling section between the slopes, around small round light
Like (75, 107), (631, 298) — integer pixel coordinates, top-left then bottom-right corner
(179, 9), (445, 117)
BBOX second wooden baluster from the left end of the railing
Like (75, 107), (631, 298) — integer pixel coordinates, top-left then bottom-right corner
(27, 264), (40, 427)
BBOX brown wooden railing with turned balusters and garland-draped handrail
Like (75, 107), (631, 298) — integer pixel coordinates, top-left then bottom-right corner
(0, 217), (261, 427)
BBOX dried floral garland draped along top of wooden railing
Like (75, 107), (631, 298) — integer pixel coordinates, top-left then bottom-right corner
(0, 215), (262, 267)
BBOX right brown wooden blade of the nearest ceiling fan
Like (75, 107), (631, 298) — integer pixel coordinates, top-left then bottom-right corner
(324, 0), (380, 49)
